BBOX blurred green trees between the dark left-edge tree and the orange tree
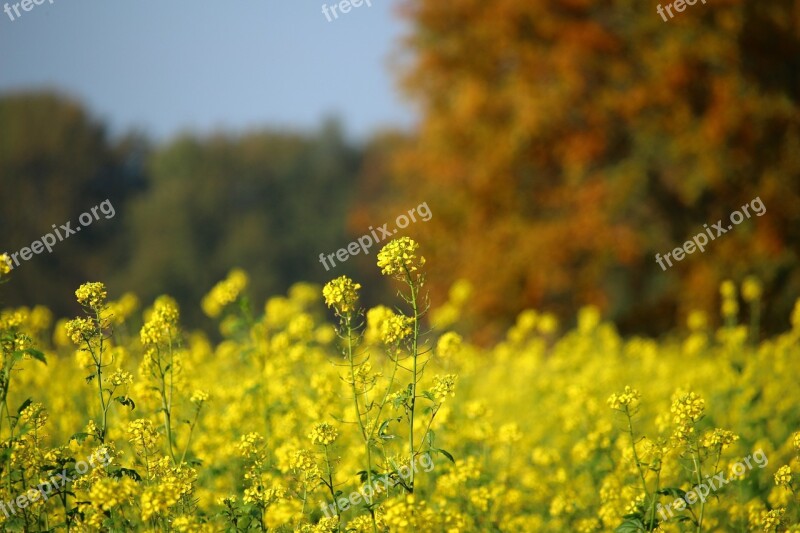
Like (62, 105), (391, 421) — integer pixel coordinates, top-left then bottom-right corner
(119, 121), (360, 320)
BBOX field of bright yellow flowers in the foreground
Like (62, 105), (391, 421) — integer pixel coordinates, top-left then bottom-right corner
(0, 238), (800, 532)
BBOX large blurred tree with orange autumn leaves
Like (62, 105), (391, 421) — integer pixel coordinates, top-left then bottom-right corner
(362, 0), (800, 335)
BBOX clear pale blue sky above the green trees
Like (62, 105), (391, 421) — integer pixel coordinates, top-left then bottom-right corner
(0, 0), (415, 140)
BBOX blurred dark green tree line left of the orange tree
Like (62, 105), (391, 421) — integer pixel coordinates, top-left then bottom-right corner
(0, 94), (361, 325)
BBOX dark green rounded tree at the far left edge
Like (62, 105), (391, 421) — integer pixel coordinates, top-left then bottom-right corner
(0, 93), (146, 314)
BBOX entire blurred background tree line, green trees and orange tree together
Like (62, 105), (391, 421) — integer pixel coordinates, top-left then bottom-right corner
(0, 0), (800, 339)
